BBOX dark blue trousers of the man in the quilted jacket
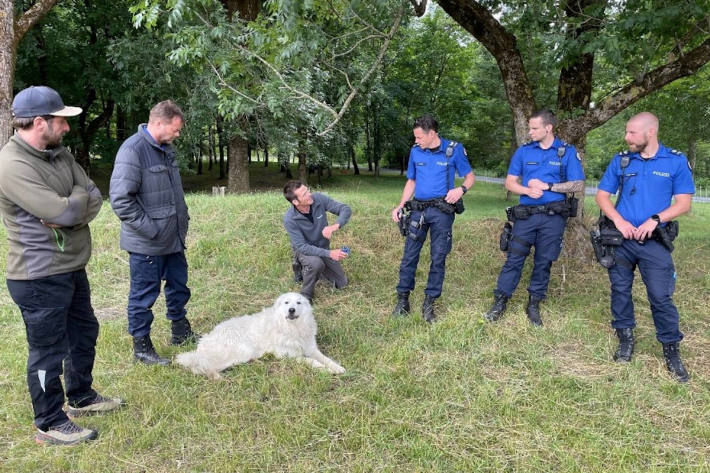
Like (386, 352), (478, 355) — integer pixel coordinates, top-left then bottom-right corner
(128, 251), (190, 337)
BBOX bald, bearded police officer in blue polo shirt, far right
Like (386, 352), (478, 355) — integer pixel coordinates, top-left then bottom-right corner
(596, 112), (695, 382)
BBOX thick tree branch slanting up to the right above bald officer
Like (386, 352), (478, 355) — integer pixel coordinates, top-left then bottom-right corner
(561, 38), (710, 142)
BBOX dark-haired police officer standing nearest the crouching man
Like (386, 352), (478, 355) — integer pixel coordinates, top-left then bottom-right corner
(392, 115), (474, 323)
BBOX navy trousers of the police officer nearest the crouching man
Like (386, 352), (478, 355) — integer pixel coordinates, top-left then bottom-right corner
(397, 207), (454, 298)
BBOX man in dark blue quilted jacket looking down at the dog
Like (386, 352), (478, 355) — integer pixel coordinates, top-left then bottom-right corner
(109, 100), (195, 365)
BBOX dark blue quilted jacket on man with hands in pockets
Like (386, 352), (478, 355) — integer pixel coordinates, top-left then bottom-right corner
(109, 124), (190, 256)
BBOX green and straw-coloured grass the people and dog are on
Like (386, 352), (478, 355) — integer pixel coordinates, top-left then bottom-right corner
(0, 170), (710, 473)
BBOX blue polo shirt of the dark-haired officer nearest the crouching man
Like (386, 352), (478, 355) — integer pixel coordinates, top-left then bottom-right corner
(407, 137), (471, 200)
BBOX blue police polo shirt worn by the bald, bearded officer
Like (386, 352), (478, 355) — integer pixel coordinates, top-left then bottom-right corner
(599, 143), (695, 227)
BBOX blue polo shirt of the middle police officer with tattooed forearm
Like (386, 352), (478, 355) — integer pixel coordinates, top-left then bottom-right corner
(508, 137), (584, 205)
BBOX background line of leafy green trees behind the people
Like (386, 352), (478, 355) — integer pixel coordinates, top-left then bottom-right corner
(0, 0), (710, 191)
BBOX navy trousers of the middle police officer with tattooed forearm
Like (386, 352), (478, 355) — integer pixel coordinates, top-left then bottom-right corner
(494, 214), (567, 300)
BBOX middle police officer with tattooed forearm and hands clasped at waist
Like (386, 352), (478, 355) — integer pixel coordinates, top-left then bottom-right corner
(484, 110), (584, 326)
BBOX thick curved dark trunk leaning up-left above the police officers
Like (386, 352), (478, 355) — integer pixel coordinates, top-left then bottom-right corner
(437, 0), (535, 144)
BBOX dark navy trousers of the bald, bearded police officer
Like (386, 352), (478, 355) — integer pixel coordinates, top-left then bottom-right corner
(609, 240), (683, 343)
